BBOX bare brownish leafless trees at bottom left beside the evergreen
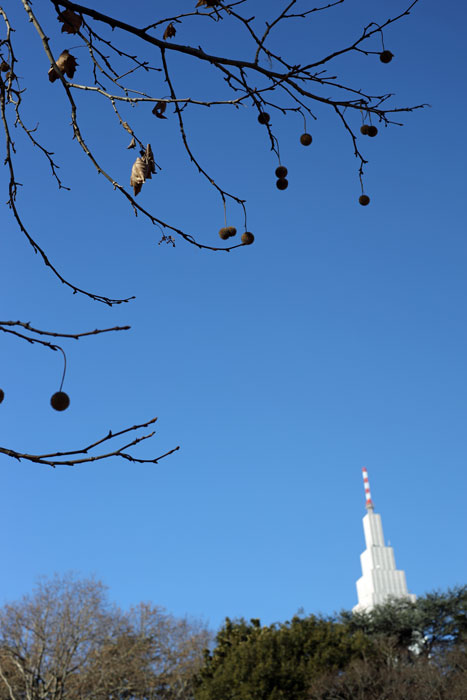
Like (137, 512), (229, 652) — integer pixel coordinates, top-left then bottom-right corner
(0, 576), (210, 700)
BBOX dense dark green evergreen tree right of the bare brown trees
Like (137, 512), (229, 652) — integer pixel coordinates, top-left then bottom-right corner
(195, 615), (368, 700)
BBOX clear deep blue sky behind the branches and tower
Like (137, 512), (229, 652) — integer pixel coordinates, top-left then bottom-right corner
(0, 0), (467, 627)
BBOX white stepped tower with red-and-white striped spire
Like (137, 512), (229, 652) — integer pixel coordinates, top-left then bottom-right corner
(353, 467), (416, 612)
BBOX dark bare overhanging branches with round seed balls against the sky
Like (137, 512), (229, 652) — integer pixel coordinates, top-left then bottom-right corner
(0, 0), (423, 466)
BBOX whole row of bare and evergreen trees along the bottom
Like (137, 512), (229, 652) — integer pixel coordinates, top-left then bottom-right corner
(0, 575), (467, 700)
